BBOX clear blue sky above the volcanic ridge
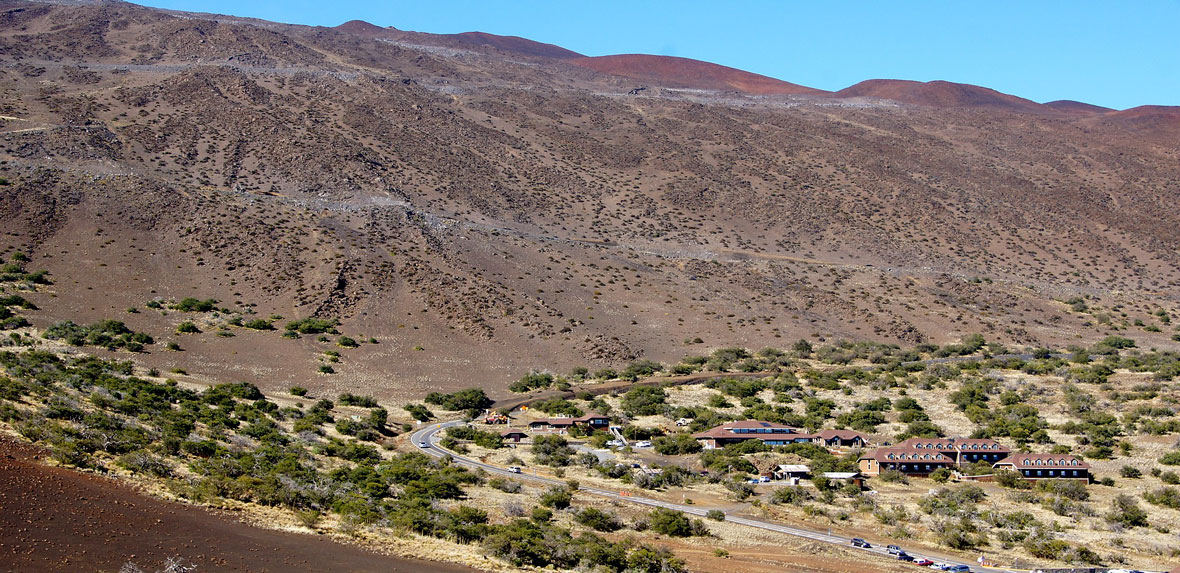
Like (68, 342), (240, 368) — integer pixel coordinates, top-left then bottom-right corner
(133, 0), (1180, 108)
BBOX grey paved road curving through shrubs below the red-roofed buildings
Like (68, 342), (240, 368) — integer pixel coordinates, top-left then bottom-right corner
(411, 420), (1012, 573)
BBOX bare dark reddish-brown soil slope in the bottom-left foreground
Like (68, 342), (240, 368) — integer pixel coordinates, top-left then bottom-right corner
(0, 436), (474, 573)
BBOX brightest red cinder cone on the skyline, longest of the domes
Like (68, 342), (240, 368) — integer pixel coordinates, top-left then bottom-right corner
(572, 54), (827, 96)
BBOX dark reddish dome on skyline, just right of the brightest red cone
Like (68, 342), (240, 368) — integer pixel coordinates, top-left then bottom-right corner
(835, 79), (1049, 113)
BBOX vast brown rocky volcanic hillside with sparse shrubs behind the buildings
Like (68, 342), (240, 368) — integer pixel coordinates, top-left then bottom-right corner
(0, 0), (1180, 397)
